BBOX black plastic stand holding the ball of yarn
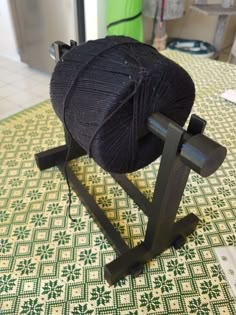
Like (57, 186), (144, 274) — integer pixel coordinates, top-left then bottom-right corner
(35, 113), (226, 285)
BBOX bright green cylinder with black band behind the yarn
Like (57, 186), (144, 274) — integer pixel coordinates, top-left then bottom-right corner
(107, 0), (143, 42)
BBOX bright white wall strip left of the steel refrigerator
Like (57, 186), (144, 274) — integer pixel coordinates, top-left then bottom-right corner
(0, 0), (20, 61)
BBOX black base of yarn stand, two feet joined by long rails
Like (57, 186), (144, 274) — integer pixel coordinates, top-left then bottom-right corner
(35, 145), (199, 285)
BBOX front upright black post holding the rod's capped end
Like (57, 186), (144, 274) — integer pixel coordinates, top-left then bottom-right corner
(144, 123), (190, 254)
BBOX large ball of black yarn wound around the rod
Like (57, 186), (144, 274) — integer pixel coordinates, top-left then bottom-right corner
(50, 36), (195, 173)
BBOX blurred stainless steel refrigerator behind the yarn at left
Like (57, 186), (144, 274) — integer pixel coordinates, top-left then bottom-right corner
(9, 0), (85, 73)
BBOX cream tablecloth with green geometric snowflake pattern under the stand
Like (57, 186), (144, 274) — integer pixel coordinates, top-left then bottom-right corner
(0, 52), (236, 315)
